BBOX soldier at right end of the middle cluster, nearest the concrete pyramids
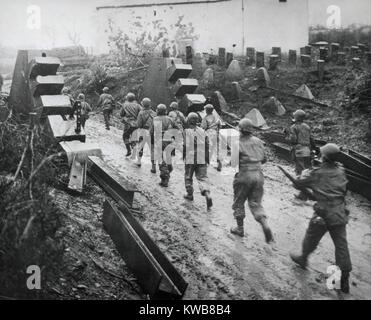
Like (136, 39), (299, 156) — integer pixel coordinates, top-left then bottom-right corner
(201, 104), (222, 171)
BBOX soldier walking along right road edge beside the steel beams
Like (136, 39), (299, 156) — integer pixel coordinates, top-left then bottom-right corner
(287, 109), (314, 200)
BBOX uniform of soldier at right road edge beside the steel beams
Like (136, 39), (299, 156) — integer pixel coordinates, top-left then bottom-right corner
(288, 122), (312, 176)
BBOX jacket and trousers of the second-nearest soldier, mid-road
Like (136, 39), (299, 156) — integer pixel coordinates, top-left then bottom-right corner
(232, 135), (266, 222)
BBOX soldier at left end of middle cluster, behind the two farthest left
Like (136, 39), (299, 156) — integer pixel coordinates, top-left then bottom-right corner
(120, 92), (142, 159)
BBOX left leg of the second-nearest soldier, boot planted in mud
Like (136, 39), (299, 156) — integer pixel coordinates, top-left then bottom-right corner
(231, 172), (250, 237)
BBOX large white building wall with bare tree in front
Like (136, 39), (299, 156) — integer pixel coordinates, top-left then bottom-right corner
(97, 0), (308, 54)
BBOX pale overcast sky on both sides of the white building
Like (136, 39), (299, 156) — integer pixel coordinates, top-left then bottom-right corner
(0, 0), (371, 49)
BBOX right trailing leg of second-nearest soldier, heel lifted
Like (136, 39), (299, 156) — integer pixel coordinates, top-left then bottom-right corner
(248, 172), (273, 243)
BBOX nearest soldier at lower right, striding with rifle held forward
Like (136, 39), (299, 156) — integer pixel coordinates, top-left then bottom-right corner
(290, 143), (352, 293)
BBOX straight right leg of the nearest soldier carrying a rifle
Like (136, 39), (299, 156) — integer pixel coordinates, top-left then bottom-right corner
(329, 225), (352, 293)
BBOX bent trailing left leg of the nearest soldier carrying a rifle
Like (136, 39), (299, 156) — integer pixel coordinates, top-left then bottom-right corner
(290, 215), (327, 269)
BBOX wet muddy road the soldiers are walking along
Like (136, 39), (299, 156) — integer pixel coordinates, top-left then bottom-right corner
(79, 115), (371, 299)
